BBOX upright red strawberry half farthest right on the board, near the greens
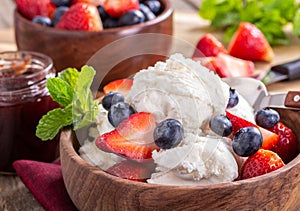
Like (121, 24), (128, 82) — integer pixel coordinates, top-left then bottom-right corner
(228, 22), (274, 62)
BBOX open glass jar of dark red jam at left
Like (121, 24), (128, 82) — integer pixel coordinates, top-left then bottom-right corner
(0, 51), (59, 174)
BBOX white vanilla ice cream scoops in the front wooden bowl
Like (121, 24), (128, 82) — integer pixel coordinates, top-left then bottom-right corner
(80, 54), (254, 185)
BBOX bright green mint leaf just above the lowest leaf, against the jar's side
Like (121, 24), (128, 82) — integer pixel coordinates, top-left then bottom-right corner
(46, 78), (74, 106)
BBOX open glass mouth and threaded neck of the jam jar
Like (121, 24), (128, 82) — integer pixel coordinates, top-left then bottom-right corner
(0, 51), (55, 92)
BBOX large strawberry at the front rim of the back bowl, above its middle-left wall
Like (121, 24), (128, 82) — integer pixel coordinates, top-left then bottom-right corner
(56, 3), (103, 31)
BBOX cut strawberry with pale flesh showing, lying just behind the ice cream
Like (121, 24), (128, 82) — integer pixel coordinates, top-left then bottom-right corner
(194, 52), (255, 78)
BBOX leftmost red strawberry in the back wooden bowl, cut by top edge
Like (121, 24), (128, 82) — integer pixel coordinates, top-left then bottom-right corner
(15, 0), (56, 20)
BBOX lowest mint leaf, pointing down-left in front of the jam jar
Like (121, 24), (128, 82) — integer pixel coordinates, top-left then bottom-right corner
(36, 106), (73, 141)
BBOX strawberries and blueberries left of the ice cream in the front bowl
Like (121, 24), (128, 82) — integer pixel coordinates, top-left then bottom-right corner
(96, 79), (184, 181)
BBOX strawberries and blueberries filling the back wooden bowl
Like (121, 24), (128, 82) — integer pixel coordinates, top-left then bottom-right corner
(16, 0), (162, 31)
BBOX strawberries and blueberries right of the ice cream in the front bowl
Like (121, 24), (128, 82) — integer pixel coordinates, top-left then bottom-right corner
(209, 97), (298, 179)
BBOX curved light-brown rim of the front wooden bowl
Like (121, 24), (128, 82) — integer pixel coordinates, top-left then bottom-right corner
(60, 129), (300, 191)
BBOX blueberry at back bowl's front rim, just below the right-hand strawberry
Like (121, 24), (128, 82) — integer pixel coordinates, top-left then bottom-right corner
(119, 10), (145, 26)
